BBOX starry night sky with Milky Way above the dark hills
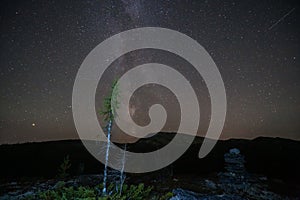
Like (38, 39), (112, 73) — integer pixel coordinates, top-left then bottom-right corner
(0, 0), (300, 144)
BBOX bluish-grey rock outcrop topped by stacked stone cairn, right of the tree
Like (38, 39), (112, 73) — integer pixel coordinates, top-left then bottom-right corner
(171, 149), (299, 200)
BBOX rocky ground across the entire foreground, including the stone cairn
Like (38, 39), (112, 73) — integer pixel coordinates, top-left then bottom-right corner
(0, 148), (300, 200)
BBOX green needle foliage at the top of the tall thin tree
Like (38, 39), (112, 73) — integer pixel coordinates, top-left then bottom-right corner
(100, 80), (120, 121)
